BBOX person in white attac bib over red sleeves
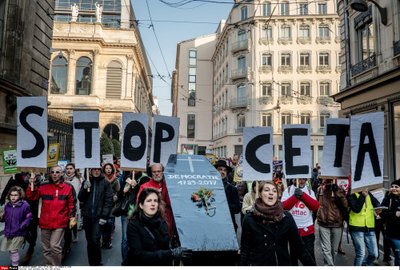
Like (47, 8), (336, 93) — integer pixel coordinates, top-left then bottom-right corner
(282, 178), (319, 265)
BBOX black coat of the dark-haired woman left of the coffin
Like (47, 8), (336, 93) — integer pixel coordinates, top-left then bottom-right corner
(123, 213), (173, 266)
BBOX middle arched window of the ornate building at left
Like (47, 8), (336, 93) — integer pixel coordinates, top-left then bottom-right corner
(76, 57), (92, 95)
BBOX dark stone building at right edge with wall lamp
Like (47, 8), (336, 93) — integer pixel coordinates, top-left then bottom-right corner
(334, 0), (400, 187)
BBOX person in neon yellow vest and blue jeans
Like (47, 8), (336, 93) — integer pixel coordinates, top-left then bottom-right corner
(348, 188), (379, 266)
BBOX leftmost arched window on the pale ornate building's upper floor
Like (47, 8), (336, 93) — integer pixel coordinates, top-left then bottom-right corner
(50, 56), (68, 94)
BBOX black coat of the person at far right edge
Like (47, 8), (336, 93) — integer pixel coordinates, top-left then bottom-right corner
(380, 194), (400, 239)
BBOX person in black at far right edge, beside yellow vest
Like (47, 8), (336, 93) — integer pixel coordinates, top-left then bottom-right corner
(381, 179), (400, 266)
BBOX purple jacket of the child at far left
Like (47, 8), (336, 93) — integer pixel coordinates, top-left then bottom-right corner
(3, 200), (32, 238)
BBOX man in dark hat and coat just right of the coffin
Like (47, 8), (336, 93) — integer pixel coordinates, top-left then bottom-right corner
(214, 159), (241, 232)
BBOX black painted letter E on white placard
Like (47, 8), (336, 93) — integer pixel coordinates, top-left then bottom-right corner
(284, 128), (310, 175)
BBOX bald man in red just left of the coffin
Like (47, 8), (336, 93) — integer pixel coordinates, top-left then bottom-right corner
(137, 163), (175, 236)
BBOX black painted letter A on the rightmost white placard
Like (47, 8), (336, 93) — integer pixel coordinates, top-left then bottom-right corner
(354, 123), (382, 181)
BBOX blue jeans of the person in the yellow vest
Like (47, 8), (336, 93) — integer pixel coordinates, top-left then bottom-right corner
(350, 231), (378, 266)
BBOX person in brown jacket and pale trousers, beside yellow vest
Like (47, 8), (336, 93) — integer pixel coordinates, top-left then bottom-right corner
(317, 178), (348, 266)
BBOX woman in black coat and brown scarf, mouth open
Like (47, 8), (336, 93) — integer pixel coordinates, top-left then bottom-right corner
(240, 181), (315, 266)
